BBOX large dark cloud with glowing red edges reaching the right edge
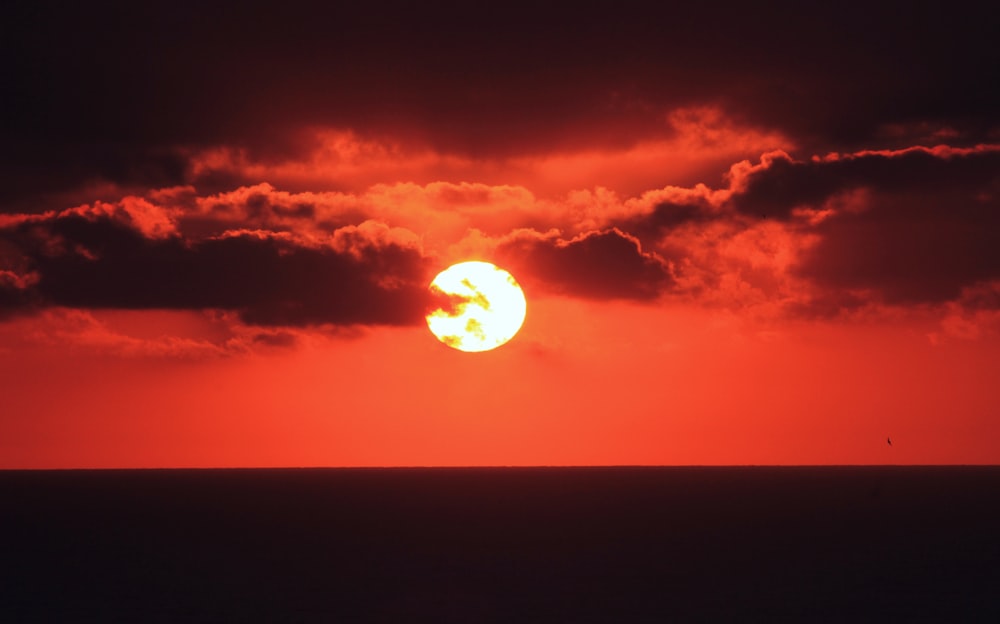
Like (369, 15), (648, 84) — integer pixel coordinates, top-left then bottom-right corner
(596, 145), (1000, 316)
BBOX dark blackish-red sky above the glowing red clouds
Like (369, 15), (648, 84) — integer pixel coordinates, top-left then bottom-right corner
(0, 1), (1000, 211)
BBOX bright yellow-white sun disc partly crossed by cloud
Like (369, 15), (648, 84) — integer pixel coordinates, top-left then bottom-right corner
(427, 261), (528, 352)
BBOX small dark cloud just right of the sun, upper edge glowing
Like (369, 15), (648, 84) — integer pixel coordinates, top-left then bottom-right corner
(496, 229), (674, 300)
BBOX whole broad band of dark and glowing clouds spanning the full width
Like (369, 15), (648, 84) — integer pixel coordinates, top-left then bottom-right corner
(0, 140), (1000, 327)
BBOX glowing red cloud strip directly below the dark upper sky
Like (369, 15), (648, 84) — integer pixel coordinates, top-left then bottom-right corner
(184, 106), (793, 197)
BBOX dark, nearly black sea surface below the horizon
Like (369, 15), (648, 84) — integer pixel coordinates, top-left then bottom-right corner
(0, 467), (1000, 623)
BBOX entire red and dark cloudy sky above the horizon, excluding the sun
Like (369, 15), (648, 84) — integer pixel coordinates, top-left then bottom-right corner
(0, 1), (1000, 468)
